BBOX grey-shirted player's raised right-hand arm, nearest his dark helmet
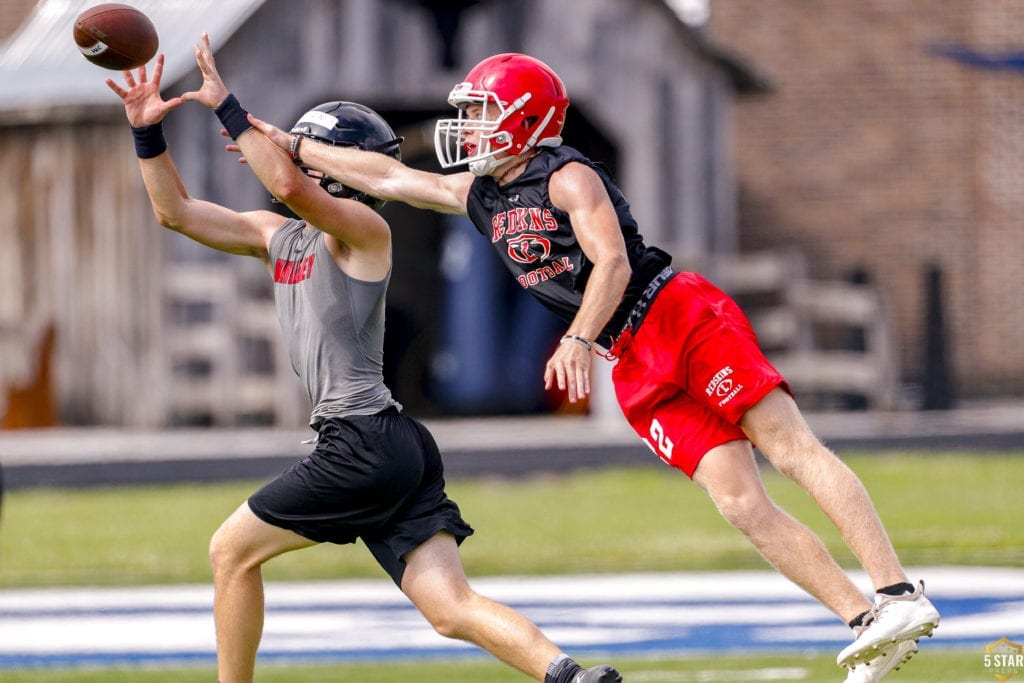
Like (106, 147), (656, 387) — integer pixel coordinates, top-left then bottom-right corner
(181, 33), (391, 281)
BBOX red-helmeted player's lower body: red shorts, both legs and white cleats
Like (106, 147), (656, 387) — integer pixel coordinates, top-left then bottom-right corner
(612, 273), (938, 664)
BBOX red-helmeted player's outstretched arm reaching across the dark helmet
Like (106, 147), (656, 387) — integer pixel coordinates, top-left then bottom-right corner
(249, 115), (473, 215)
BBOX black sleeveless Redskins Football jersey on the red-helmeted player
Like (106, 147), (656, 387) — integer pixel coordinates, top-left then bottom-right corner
(466, 145), (672, 348)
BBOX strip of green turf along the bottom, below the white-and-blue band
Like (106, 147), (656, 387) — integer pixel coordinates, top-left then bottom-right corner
(3, 643), (995, 683)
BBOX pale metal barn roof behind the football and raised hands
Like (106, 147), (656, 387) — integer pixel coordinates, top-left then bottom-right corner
(0, 0), (263, 120)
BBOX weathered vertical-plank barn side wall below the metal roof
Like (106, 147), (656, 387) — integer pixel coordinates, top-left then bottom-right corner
(0, 122), (163, 425)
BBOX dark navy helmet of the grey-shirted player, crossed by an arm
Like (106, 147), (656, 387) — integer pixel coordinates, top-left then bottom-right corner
(291, 100), (402, 209)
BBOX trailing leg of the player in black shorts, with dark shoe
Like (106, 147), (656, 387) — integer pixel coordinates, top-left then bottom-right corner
(401, 531), (622, 683)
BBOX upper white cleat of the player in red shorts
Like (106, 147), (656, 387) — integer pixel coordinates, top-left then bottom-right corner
(836, 582), (939, 669)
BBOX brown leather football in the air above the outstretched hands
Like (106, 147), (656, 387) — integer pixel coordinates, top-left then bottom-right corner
(75, 2), (160, 71)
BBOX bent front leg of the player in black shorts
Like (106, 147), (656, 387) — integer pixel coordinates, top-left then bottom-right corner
(210, 503), (315, 683)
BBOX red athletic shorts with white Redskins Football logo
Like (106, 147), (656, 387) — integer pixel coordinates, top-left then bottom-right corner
(611, 272), (790, 477)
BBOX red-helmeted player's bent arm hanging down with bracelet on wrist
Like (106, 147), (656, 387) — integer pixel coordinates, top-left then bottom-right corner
(544, 163), (631, 402)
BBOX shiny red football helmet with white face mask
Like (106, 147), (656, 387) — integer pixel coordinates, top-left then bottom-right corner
(434, 52), (569, 175)
